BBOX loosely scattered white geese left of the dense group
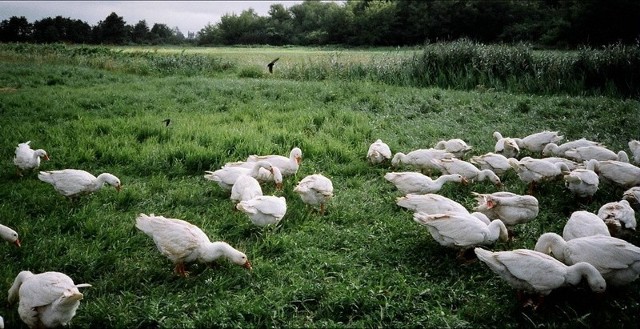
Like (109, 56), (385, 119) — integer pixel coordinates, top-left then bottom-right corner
(6, 142), (333, 328)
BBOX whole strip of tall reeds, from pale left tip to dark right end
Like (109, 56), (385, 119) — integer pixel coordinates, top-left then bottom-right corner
(283, 39), (640, 97)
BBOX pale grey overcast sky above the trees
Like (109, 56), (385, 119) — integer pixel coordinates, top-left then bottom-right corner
(0, 1), (302, 36)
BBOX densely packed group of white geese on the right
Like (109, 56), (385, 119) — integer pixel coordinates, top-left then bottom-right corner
(368, 131), (640, 309)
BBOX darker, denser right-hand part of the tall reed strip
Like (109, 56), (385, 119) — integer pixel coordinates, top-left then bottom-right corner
(406, 40), (640, 97)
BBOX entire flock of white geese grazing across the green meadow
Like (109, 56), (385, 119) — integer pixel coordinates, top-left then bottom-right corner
(5, 131), (640, 328)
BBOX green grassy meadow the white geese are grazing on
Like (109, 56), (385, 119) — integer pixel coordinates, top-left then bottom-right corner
(0, 45), (640, 328)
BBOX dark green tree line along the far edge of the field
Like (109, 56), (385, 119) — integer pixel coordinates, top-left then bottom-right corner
(0, 0), (640, 48)
